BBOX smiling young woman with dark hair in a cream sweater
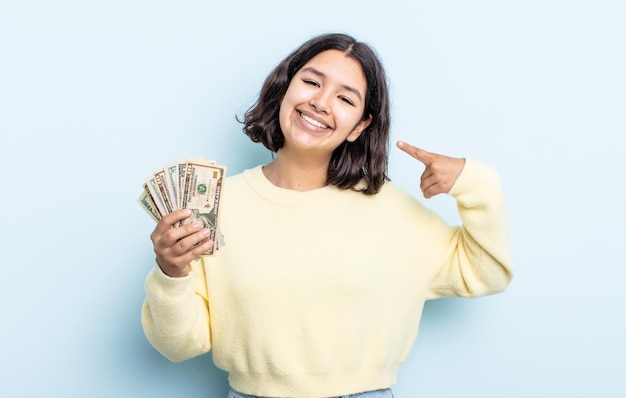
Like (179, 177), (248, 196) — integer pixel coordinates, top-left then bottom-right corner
(142, 34), (512, 398)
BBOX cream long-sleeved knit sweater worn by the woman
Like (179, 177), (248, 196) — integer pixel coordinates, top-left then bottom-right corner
(142, 159), (512, 398)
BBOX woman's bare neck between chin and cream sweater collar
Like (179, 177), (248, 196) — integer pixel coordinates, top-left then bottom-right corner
(263, 151), (328, 192)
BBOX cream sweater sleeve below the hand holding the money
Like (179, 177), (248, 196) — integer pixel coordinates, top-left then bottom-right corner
(141, 260), (211, 362)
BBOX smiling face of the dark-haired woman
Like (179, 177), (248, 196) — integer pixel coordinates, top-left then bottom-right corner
(279, 50), (371, 157)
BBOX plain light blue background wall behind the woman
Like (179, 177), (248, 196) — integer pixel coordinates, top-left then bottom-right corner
(0, 0), (626, 398)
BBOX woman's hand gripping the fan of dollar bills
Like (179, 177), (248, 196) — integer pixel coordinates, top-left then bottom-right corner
(150, 209), (213, 278)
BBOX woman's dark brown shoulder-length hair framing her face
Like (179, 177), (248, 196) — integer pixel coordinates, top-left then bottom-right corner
(242, 33), (390, 195)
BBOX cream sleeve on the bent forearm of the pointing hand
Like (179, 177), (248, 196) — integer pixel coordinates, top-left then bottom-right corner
(428, 159), (513, 299)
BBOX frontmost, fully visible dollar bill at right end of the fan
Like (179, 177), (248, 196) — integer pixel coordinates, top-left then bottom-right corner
(179, 160), (226, 256)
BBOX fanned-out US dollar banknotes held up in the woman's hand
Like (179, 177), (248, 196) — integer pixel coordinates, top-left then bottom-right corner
(137, 158), (226, 256)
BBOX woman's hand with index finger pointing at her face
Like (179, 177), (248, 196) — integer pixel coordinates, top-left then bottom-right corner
(397, 141), (465, 199)
